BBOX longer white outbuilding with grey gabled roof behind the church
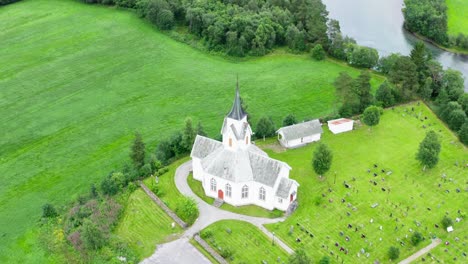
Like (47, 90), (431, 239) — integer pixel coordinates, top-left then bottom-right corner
(276, 119), (323, 148)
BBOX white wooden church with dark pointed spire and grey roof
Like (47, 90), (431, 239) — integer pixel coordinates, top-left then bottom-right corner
(190, 85), (299, 211)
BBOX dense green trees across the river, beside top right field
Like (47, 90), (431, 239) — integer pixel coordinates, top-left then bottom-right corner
(403, 0), (468, 49)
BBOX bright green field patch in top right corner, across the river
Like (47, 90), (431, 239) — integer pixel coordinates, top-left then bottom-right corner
(446, 0), (468, 36)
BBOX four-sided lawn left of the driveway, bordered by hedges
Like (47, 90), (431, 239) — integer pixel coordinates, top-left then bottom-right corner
(114, 189), (182, 258)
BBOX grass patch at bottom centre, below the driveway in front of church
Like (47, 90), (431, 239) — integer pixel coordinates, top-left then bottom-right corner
(202, 220), (288, 263)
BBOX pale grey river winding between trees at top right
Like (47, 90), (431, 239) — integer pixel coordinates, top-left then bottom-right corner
(322, 0), (468, 92)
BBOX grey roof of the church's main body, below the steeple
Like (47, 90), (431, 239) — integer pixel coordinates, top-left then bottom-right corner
(191, 136), (291, 187)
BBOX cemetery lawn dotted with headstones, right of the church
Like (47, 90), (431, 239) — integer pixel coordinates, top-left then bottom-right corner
(264, 103), (468, 263)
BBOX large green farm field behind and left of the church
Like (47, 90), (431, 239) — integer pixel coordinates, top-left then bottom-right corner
(0, 0), (382, 263)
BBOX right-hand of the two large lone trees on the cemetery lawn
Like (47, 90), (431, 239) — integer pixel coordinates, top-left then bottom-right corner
(416, 130), (441, 168)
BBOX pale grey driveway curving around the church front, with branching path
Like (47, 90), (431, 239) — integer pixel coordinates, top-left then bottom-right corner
(143, 160), (293, 264)
